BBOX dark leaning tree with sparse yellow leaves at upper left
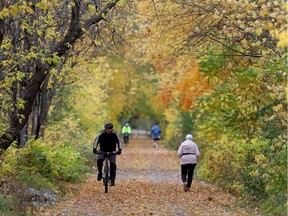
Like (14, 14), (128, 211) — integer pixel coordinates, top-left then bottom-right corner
(0, 0), (119, 154)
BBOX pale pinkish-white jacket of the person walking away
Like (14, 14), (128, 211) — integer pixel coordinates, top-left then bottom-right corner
(177, 139), (200, 164)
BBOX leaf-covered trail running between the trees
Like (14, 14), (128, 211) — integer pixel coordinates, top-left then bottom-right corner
(38, 140), (257, 216)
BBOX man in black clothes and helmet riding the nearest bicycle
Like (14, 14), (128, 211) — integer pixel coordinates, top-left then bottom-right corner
(93, 122), (122, 186)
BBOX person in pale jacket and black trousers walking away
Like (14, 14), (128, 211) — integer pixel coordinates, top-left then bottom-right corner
(177, 134), (200, 192)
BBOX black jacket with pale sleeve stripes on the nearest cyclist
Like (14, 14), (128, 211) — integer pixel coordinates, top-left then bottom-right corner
(93, 130), (122, 152)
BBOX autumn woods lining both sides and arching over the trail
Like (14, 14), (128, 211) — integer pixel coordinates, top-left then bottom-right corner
(0, 0), (287, 215)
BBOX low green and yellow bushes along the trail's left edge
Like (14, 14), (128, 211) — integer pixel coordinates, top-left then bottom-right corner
(0, 117), (92, 215)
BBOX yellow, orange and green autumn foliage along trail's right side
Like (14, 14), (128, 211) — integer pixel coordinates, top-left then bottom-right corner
(132, 0), (287, 215)
